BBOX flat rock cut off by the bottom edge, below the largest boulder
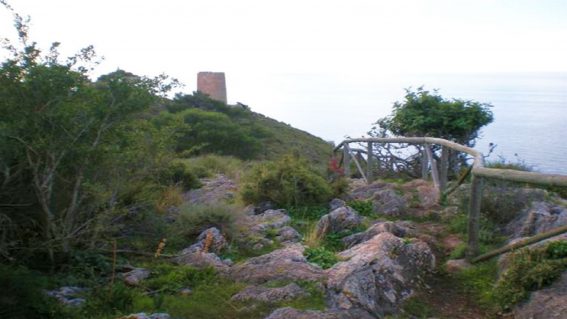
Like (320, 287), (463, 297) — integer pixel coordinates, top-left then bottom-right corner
(265, 307), (374, 319)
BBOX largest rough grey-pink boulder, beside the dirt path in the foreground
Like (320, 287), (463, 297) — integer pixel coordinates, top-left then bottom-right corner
(327, 232), (435, 317)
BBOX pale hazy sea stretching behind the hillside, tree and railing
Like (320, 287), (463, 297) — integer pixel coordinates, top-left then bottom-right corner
(247, 72), (567, 175)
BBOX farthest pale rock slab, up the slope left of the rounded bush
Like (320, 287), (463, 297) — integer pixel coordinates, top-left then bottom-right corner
(184, 174), (237, 205)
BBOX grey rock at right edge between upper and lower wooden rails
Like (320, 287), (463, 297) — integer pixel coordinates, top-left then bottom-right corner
(506, 202), (567, 238)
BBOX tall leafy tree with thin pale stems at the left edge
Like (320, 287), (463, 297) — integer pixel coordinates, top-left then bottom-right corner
(0, 3), (176, 260)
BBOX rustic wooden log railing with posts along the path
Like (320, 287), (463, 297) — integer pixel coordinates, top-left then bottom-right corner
(334, 137), (567, 260)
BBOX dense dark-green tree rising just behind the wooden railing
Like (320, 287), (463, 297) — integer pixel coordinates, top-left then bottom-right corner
(371, 87), (493, 146)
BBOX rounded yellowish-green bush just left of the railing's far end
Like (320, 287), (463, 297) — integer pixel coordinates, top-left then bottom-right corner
(241, 155), (332, 207)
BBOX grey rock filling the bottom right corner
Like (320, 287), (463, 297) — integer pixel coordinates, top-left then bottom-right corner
(514, 272), (567, 319)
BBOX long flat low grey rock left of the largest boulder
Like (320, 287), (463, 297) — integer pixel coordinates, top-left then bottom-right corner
(231, 283), (309, 303)
